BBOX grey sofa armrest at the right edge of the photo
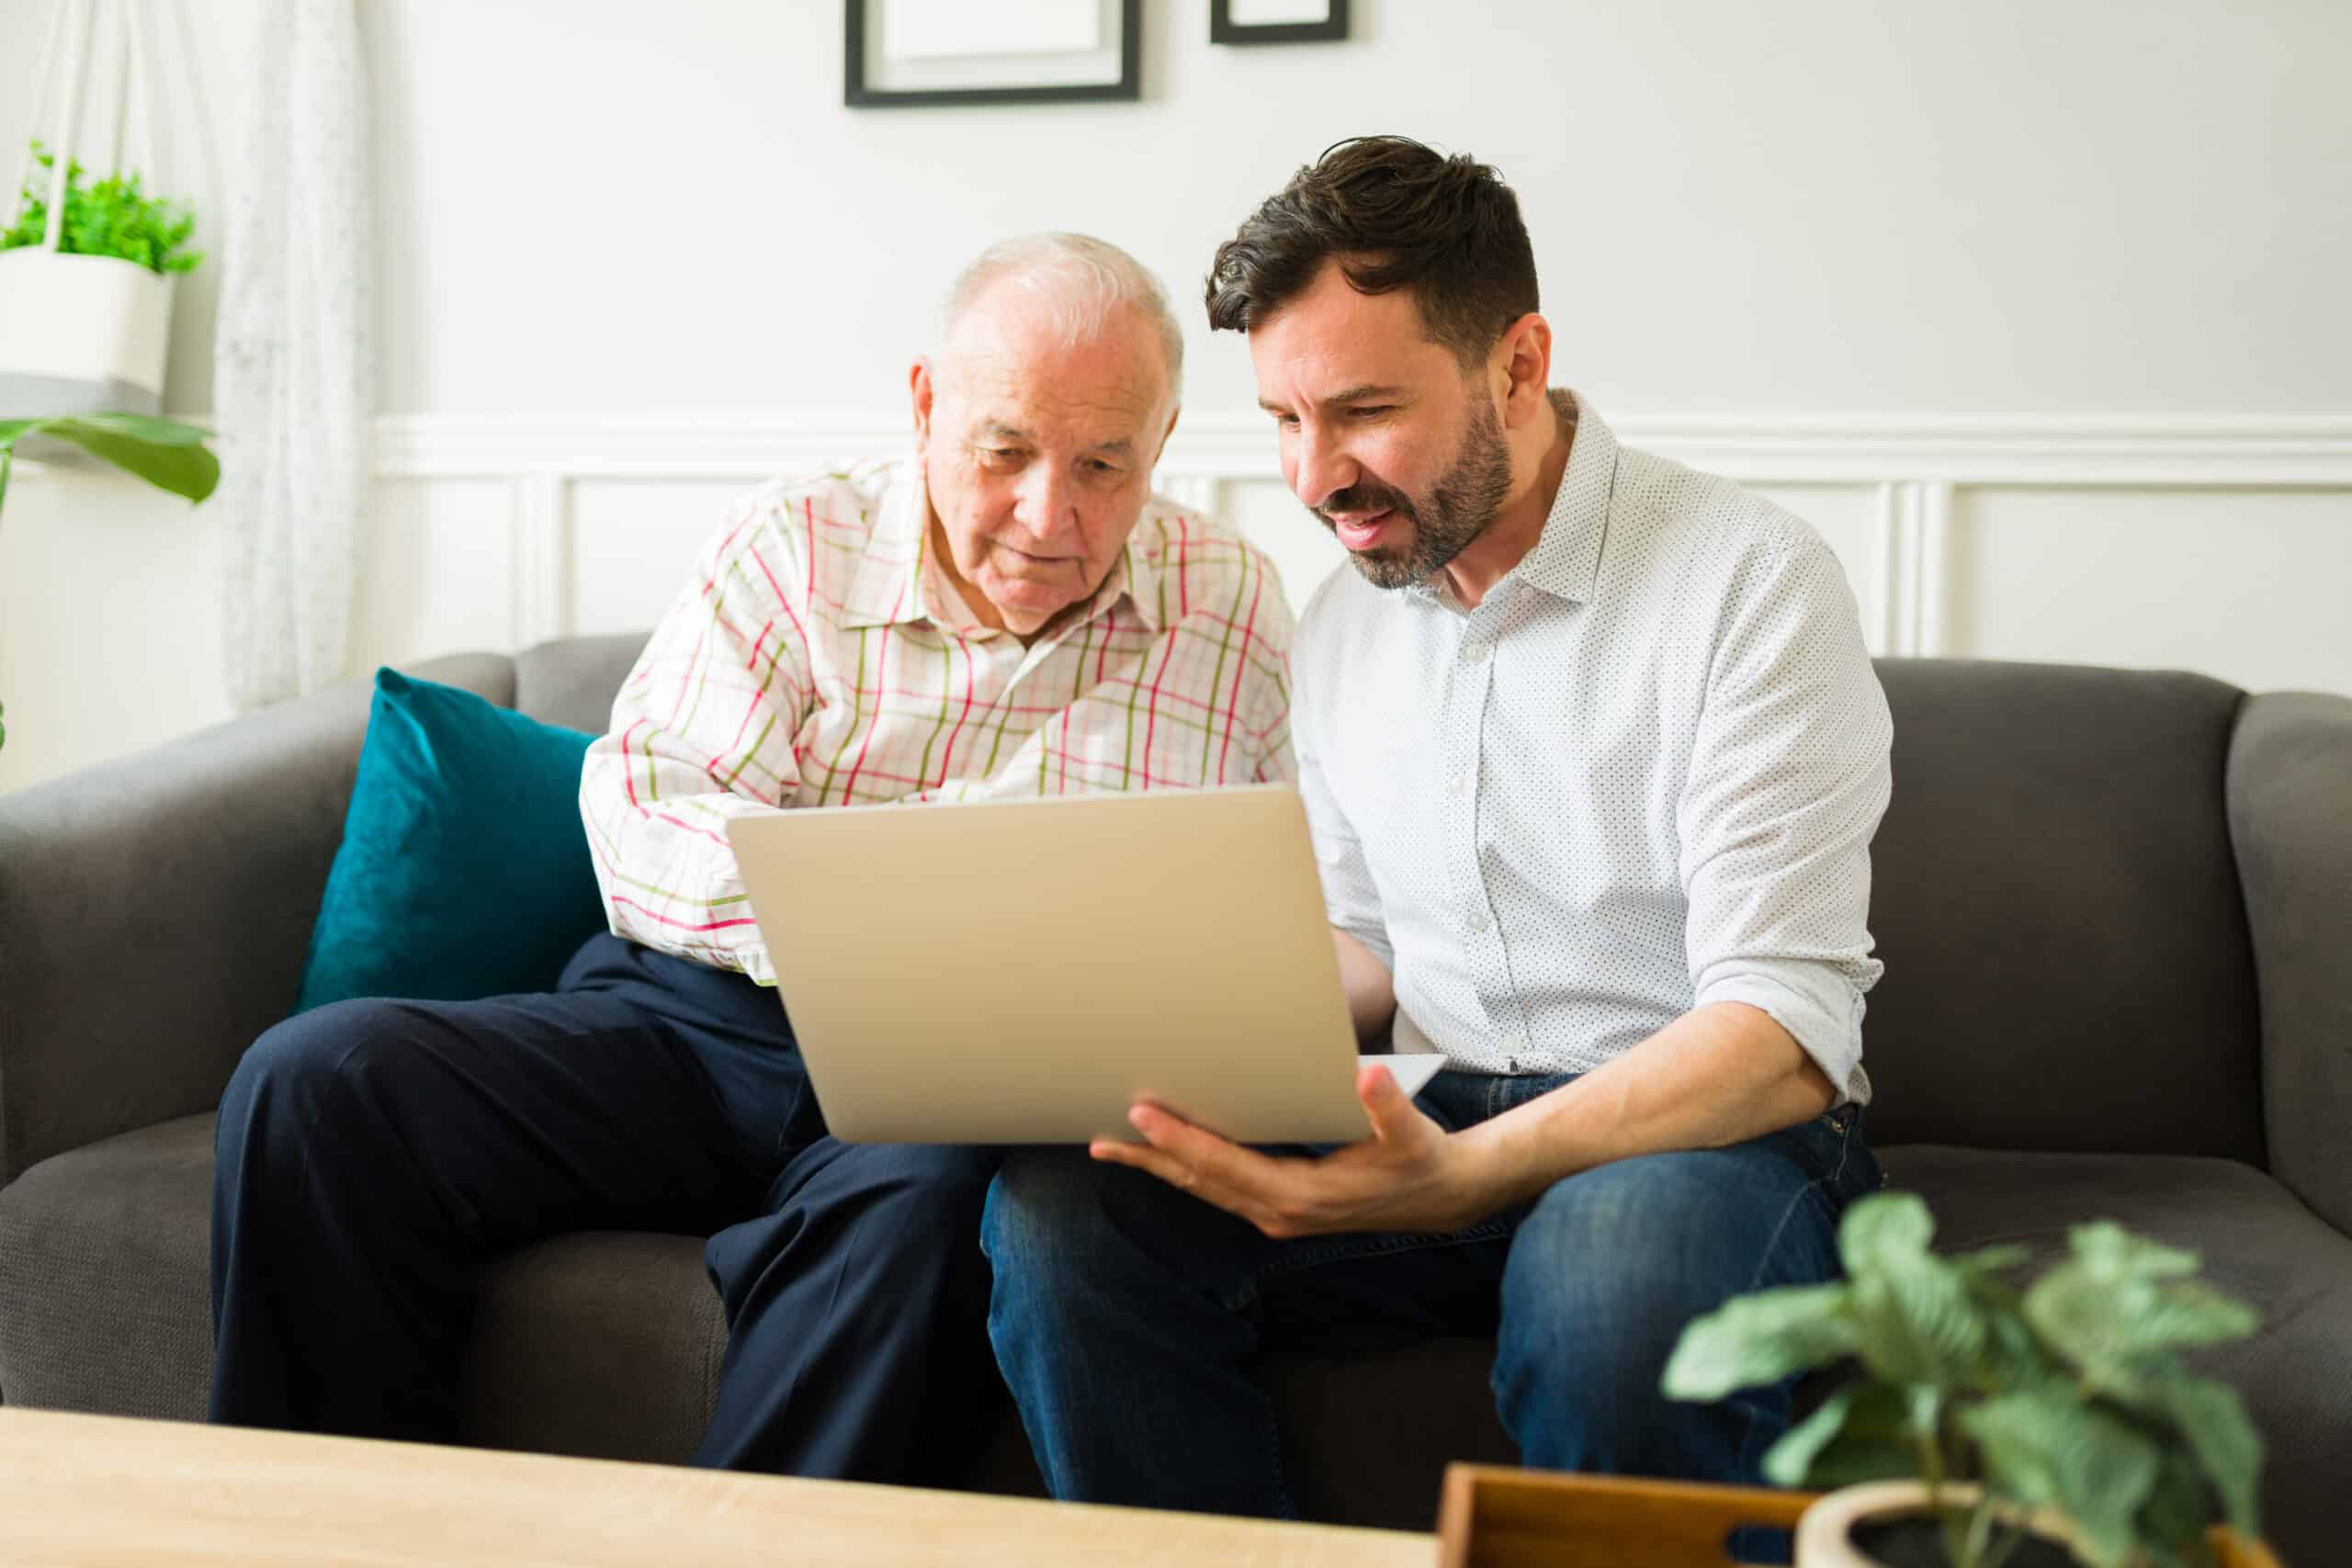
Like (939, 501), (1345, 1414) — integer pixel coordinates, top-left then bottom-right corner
(2227, 691), (2352, 1235)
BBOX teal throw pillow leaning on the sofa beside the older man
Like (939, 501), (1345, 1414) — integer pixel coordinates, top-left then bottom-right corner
(294, 670), (605, 1010)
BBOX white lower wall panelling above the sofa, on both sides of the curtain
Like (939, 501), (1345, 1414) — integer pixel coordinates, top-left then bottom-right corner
(0, 412), (2352, 790)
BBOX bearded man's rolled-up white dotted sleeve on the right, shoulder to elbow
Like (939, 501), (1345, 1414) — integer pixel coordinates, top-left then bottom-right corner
(1679, 536), (1894, 1100)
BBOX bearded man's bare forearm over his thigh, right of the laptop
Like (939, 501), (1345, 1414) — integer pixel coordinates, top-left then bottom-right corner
(1461, 1001), (1837, 1213)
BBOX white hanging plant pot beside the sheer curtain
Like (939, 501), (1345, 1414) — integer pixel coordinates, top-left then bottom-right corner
(0, 244), (174, 419)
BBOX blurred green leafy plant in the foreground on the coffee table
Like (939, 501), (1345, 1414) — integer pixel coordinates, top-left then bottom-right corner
(1663, 1192), (2263, 1568)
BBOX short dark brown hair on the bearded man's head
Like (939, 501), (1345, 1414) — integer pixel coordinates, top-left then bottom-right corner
(1206, 136), (1536, 365)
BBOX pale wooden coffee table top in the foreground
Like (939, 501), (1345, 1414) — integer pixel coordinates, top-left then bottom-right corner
(0, 1408), (1437, 1568)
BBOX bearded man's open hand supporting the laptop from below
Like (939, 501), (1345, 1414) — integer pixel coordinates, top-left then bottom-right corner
(1087, 1067), (1496, 1239)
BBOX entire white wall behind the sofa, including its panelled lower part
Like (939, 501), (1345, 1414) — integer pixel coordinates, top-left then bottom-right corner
(0, 0), (2352, 787)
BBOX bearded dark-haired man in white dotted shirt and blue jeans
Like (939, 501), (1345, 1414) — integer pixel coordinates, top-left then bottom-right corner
(983, 136), (1891, 1514)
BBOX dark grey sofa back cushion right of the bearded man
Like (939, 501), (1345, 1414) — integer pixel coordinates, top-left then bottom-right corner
(1863, 659), (2263, 1164)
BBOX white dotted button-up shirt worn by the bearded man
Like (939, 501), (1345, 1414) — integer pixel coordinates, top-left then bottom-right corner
(1291, 392), (1894, 1100)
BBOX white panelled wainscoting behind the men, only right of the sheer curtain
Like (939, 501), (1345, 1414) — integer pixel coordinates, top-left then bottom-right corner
(353, 413), (2352, 691)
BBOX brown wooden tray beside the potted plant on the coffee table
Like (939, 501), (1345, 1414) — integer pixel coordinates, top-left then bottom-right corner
(1437, 1464), (2281, 1568)
